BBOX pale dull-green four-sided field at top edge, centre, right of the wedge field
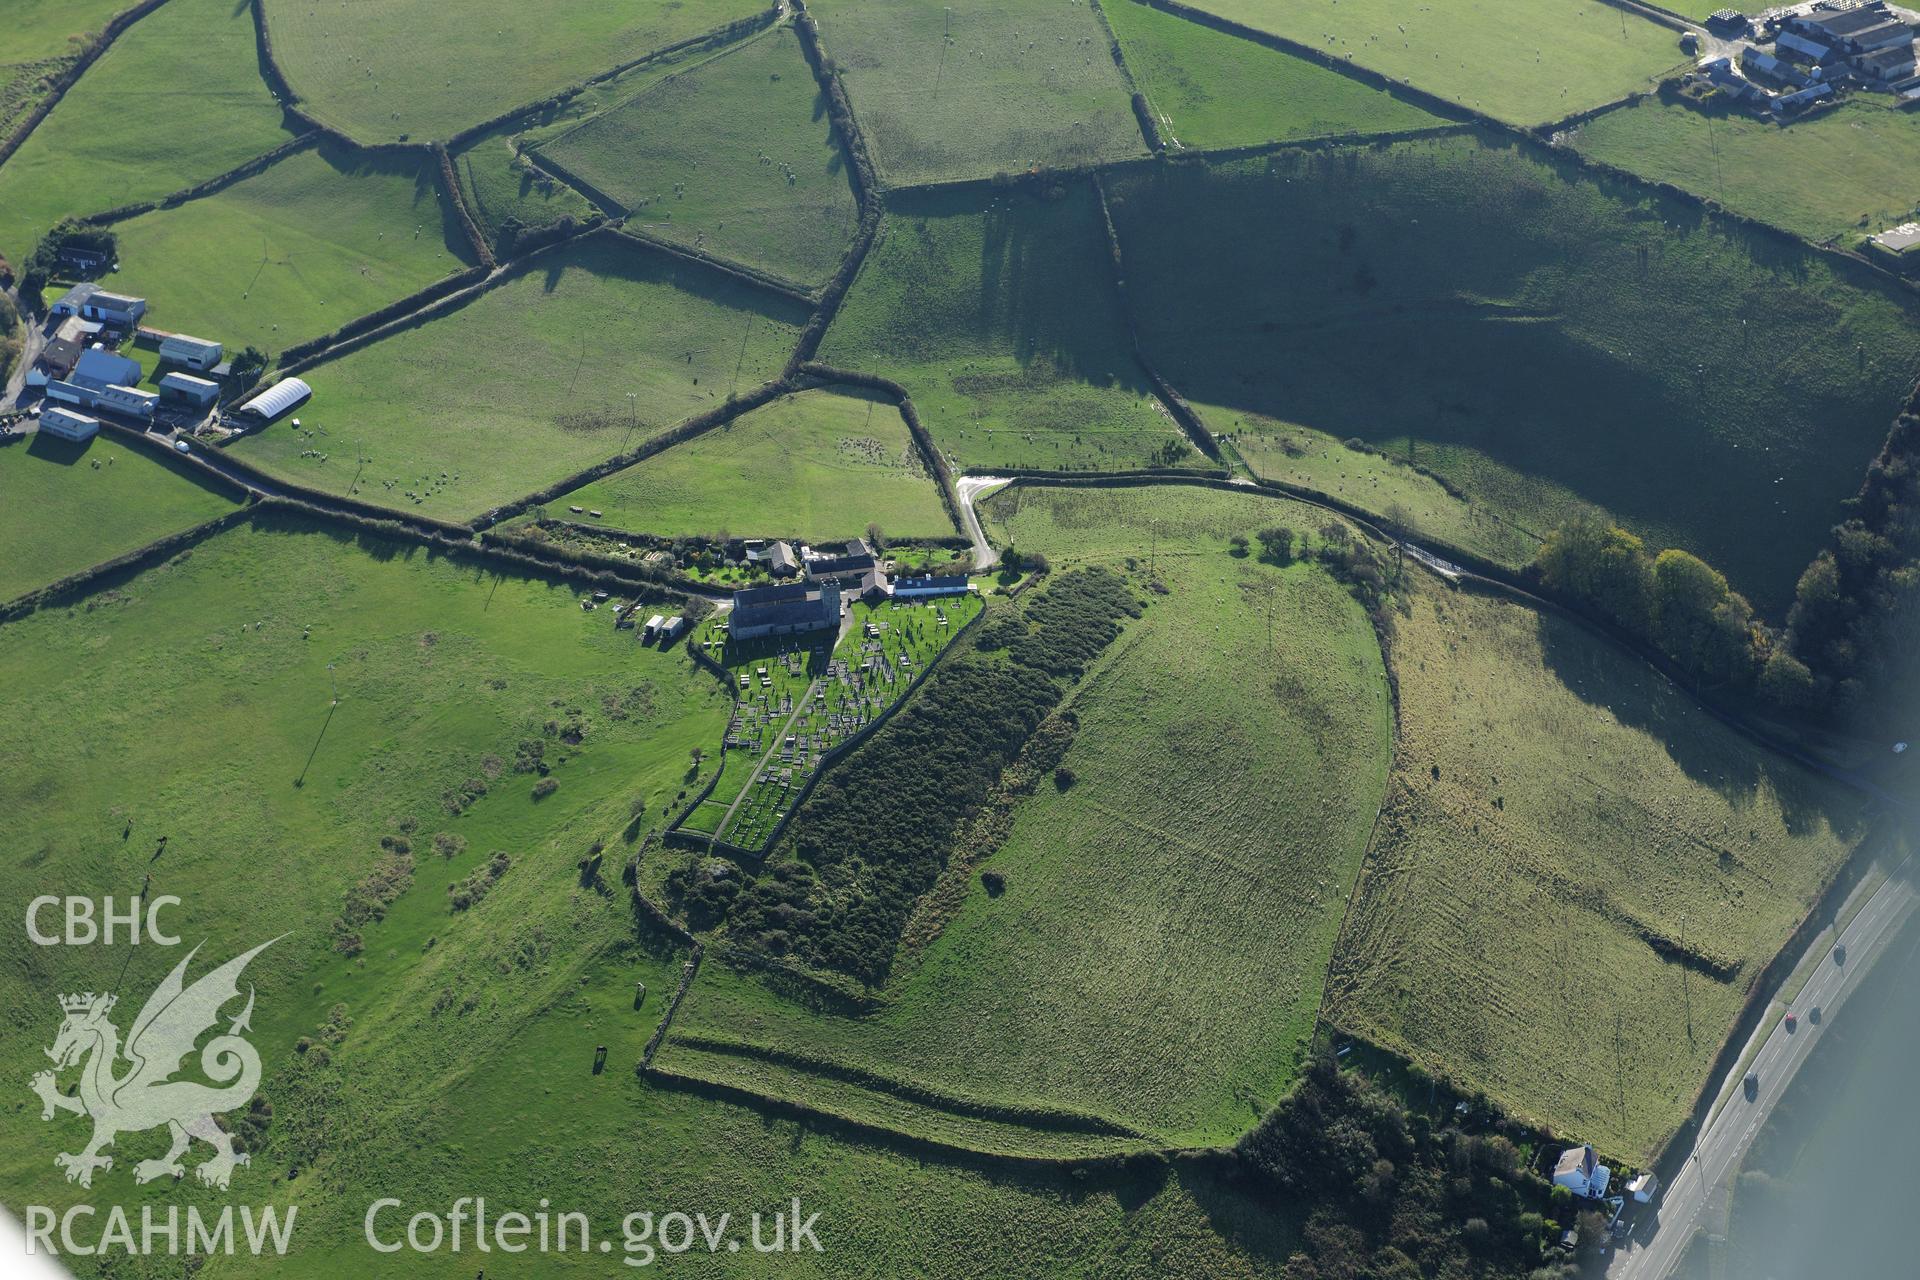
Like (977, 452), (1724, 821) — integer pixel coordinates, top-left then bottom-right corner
(808, 0), (1146, 184)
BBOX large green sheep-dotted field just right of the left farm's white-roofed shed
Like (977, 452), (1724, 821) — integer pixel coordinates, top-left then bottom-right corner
(238, 240), (804, 518)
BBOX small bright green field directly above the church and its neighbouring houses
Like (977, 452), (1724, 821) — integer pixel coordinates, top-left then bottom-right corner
(555, 383), (954, 541)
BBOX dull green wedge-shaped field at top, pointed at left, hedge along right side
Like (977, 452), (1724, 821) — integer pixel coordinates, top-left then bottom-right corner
(540, 27), (856, 284)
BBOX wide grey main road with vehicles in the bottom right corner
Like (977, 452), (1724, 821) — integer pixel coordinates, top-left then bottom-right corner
(1607, 862), (1920, 1280)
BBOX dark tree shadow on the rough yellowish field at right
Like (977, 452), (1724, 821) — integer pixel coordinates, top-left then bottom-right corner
(1540, 614), (1860, 837)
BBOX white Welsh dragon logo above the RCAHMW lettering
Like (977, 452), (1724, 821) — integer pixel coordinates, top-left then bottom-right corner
(33, 938), (278, 1190)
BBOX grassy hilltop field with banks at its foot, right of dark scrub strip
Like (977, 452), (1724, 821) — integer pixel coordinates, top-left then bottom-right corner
(660, 487), (1388, 1151)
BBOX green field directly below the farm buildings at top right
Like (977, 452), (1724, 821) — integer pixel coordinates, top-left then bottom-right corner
(1572, 94), (1920, 244)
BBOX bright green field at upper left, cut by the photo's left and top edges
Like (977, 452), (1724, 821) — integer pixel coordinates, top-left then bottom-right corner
(0, 0), (288, 263)
